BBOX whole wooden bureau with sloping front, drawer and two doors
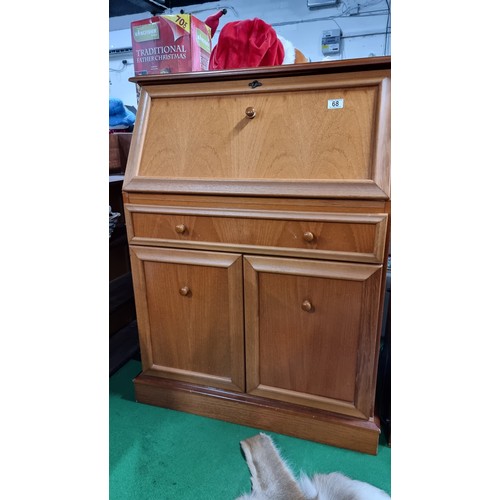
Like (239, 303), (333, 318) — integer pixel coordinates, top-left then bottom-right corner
(123, 57), (390, 454)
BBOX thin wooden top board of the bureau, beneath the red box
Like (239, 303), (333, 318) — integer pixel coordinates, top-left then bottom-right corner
(130, 56), (391, 86)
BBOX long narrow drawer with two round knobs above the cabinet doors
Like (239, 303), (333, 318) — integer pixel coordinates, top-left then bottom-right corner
(126, 205), (388, 263)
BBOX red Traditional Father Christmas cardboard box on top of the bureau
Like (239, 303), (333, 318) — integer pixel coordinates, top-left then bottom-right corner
(130, 14), (212, 76)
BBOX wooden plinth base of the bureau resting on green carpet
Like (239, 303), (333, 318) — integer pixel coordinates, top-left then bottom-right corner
(134, 374), (380, 455)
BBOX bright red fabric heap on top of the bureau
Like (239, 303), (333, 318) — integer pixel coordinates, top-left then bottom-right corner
(208, 18), (285, 70)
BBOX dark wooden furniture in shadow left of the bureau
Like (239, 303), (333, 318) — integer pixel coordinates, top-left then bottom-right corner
(109, 133), (139, 375)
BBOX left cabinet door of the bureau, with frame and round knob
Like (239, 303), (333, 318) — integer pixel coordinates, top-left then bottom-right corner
(130, 245), (245, 392)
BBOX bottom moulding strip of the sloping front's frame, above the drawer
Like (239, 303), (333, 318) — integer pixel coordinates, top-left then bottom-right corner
(123, 177), (388, 200)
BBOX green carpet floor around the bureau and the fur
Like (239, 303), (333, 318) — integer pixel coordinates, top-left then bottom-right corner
(109, 360), (391, 500)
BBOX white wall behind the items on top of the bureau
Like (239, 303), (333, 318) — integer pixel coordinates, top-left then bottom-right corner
(109, 0), (391, 106)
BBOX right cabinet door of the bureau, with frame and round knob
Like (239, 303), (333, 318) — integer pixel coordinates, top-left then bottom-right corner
(244, 256), (382, 419)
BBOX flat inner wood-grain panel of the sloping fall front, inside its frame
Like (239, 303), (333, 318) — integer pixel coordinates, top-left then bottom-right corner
(139, 87), (377, 180)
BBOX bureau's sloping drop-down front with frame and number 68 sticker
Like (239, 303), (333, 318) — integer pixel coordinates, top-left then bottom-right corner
(125, 72), (390, 199)
